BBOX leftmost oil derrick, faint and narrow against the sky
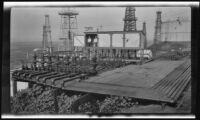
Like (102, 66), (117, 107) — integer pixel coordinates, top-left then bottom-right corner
(42, 15), (52, 52)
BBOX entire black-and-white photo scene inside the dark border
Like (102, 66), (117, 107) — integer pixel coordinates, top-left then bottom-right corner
(1, 2), (199, 117)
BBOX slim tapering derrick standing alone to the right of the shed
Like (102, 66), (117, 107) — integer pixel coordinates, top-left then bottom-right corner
(154, 11), (162, 44)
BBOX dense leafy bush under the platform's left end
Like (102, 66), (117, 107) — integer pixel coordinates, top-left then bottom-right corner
(11, 85), (55, 114)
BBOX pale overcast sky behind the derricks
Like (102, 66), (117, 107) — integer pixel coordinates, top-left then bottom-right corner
(11, 7), (191, 41)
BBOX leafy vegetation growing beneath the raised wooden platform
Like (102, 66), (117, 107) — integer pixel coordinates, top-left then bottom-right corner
(11, 85), (137, 114)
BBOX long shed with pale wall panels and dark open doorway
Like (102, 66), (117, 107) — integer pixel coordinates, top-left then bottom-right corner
(85, 31), (145, 49)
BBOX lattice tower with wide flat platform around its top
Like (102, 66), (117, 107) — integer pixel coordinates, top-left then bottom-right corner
(59, 8), (78, 51)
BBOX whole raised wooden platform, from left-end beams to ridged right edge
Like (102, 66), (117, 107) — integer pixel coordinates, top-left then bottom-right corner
(13, 59), (191, 103)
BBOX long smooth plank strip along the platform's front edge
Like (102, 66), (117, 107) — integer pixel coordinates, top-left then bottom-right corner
(63, 82), (171, 102)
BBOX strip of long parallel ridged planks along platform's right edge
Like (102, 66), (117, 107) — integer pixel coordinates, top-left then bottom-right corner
(152, 61), (191, 102)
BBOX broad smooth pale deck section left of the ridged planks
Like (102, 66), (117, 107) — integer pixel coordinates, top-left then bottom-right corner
(85, 61), (184, 87)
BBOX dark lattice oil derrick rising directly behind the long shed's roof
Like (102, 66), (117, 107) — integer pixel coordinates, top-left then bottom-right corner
(124, 7), (137, 31)
